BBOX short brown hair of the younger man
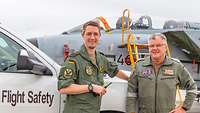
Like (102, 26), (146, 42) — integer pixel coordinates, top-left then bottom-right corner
(81, 21), (101, 36)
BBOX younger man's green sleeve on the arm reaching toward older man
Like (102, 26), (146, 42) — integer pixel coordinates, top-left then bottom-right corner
(105, 58), (119, 78)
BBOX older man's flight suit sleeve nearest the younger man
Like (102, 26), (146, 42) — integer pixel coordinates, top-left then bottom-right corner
(126, 66), (138, 113)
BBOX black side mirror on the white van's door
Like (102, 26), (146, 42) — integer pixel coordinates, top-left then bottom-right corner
(17, 49), (52, 75)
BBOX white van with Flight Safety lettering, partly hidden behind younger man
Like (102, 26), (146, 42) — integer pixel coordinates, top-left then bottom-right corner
(0, 25), (130, 113)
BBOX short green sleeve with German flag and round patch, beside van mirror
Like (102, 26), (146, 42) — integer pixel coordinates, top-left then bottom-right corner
(58, 59), (77, 89)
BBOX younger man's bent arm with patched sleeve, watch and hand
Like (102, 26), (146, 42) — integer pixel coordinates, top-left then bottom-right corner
(58, 59), (106, 95)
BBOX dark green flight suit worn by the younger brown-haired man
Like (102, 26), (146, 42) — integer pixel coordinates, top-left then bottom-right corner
(58, 45), (118, 113)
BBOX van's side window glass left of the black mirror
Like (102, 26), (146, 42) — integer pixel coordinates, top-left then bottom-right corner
(0, 32), (23, 72)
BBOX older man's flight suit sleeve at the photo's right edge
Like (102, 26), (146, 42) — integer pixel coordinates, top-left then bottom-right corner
(179, 65), (197, 110)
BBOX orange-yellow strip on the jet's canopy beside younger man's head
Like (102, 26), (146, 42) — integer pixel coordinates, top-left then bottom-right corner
(97, 16), (111, 33)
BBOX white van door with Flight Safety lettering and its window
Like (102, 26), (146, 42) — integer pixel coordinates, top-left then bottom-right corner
(0, 32), (60, 113)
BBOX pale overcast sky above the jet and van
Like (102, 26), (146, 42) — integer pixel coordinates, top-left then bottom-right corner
(0, 0), (200, 38)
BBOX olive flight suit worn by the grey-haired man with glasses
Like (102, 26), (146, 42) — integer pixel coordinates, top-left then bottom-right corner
(127, 57), (197, 113)
